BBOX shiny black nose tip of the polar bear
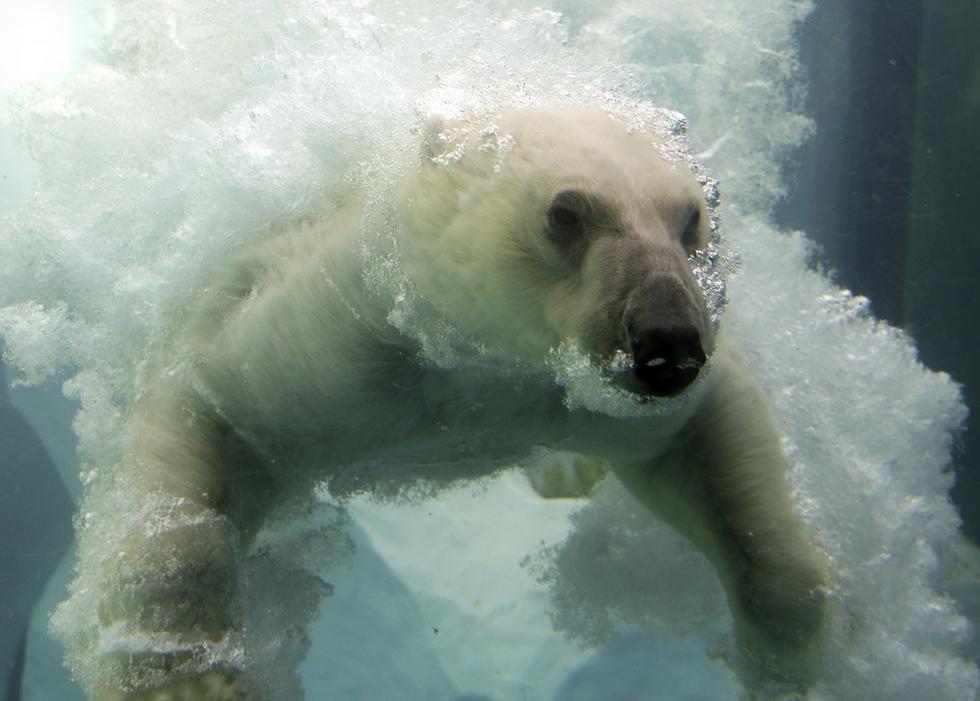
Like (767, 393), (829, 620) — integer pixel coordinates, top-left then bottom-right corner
(628, 325), (707, 397)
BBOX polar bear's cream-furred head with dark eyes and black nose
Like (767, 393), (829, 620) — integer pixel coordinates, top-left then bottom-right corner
(399, 108), (714, 396)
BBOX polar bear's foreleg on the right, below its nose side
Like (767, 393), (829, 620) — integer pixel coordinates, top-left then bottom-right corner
(614, 356), (828, 672)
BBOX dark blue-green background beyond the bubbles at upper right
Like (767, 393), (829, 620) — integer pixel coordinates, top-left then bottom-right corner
(777, 0), (980, 542)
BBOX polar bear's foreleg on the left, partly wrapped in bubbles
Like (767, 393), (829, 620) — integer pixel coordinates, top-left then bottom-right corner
(83, 382), (271, 701)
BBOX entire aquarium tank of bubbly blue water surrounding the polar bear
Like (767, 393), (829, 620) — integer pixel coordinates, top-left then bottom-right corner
(0, 0), (980, 701)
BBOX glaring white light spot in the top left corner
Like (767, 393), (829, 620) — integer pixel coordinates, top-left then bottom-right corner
(0, 2), (72, 90)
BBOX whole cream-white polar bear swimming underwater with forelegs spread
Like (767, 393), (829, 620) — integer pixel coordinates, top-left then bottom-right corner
(63, 108), (828, 700)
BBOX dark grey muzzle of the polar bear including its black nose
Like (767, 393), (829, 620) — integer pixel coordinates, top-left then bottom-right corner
(623, 276), (707, 397)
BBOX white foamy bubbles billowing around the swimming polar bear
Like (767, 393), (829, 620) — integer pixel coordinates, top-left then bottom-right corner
(0, 0), (980, 700)
